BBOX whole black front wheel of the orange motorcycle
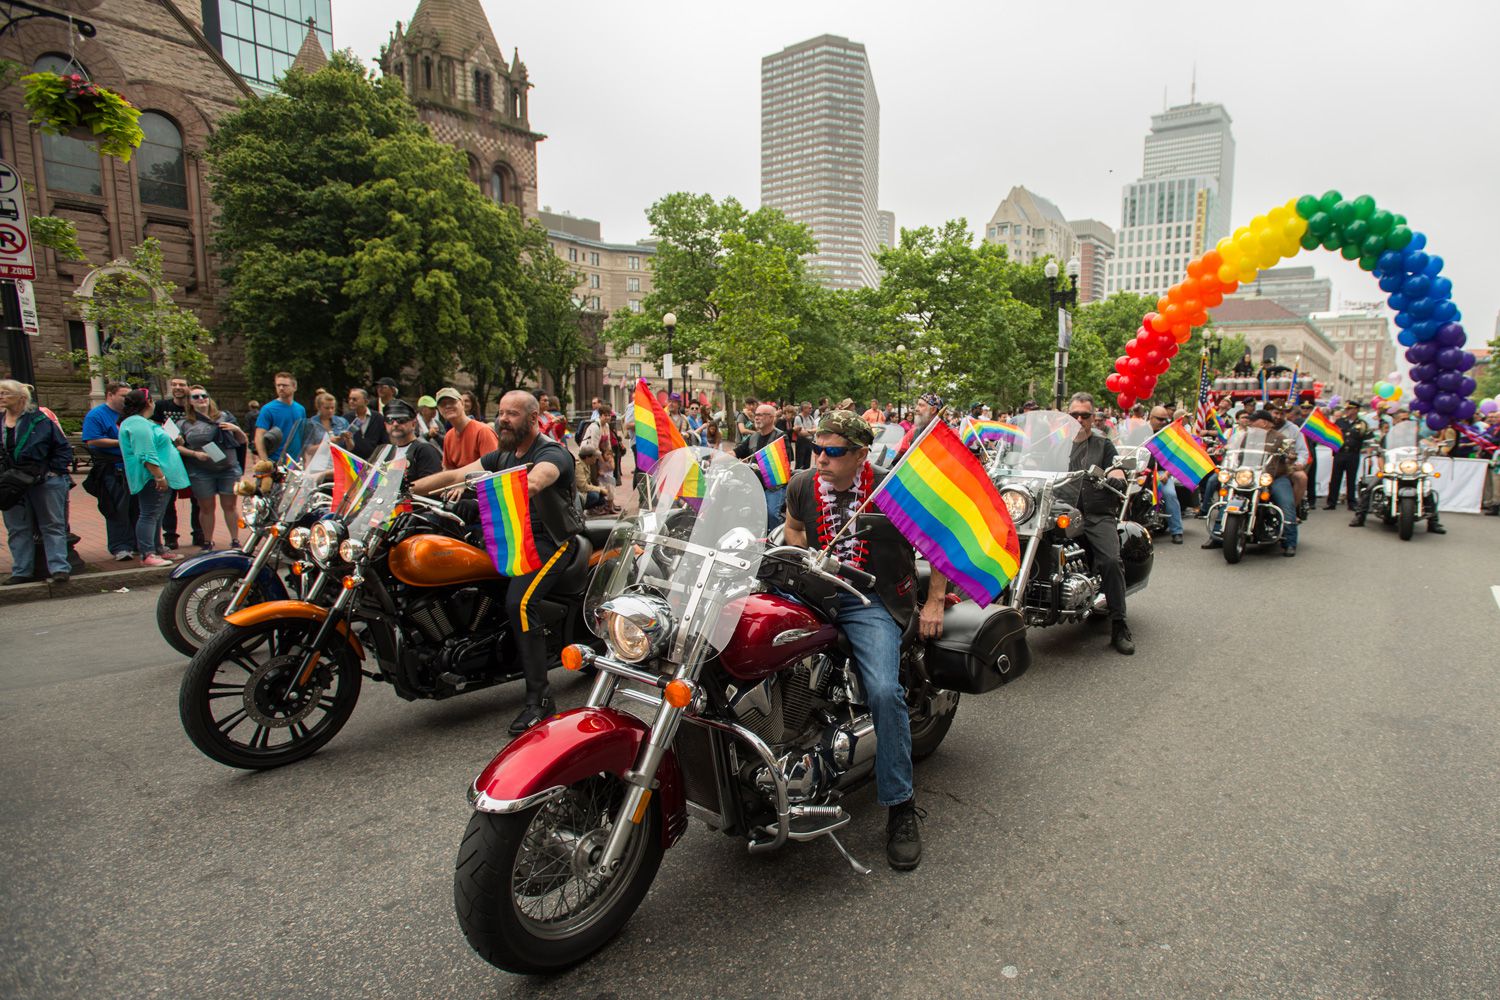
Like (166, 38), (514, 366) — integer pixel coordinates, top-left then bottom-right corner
(177, 619), (362, 769)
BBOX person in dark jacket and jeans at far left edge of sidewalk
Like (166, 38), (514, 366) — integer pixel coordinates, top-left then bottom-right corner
(0, 379), (74, 586)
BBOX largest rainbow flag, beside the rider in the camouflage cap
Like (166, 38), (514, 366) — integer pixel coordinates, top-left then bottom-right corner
(875, 420), (1020, 607)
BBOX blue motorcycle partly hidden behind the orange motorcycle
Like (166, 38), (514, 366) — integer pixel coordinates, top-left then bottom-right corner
(156, 466), (329, 657)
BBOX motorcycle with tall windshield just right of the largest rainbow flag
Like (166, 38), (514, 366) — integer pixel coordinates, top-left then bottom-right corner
(987, 409), (1157, 627)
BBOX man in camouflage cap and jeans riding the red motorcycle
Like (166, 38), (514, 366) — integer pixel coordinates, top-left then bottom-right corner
(786, 409), (948, 871)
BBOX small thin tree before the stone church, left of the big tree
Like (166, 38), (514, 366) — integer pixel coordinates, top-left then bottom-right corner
(54, 238), (213, 391)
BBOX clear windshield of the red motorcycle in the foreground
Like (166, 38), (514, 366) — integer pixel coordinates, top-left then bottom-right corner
(585, 448), (767, 663)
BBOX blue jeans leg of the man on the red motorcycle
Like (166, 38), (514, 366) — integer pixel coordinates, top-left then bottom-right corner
(834, 590), (912, 807)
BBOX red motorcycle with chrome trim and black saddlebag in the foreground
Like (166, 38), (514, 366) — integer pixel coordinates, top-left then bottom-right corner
(453, 450), (1029, 973)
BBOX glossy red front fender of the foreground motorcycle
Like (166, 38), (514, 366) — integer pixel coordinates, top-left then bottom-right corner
(468, 706), (687, 847)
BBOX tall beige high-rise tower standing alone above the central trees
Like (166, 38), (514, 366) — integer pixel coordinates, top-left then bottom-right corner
(761, 34), (881, 288)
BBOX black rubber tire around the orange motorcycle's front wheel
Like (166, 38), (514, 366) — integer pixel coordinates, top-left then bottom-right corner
(177, 619), (365, 771)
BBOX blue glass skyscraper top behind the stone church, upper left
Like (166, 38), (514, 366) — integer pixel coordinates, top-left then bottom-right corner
(203, 0), (333, 90)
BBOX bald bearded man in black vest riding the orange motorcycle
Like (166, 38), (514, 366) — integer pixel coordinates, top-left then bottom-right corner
(423, 390), (584, 733)
